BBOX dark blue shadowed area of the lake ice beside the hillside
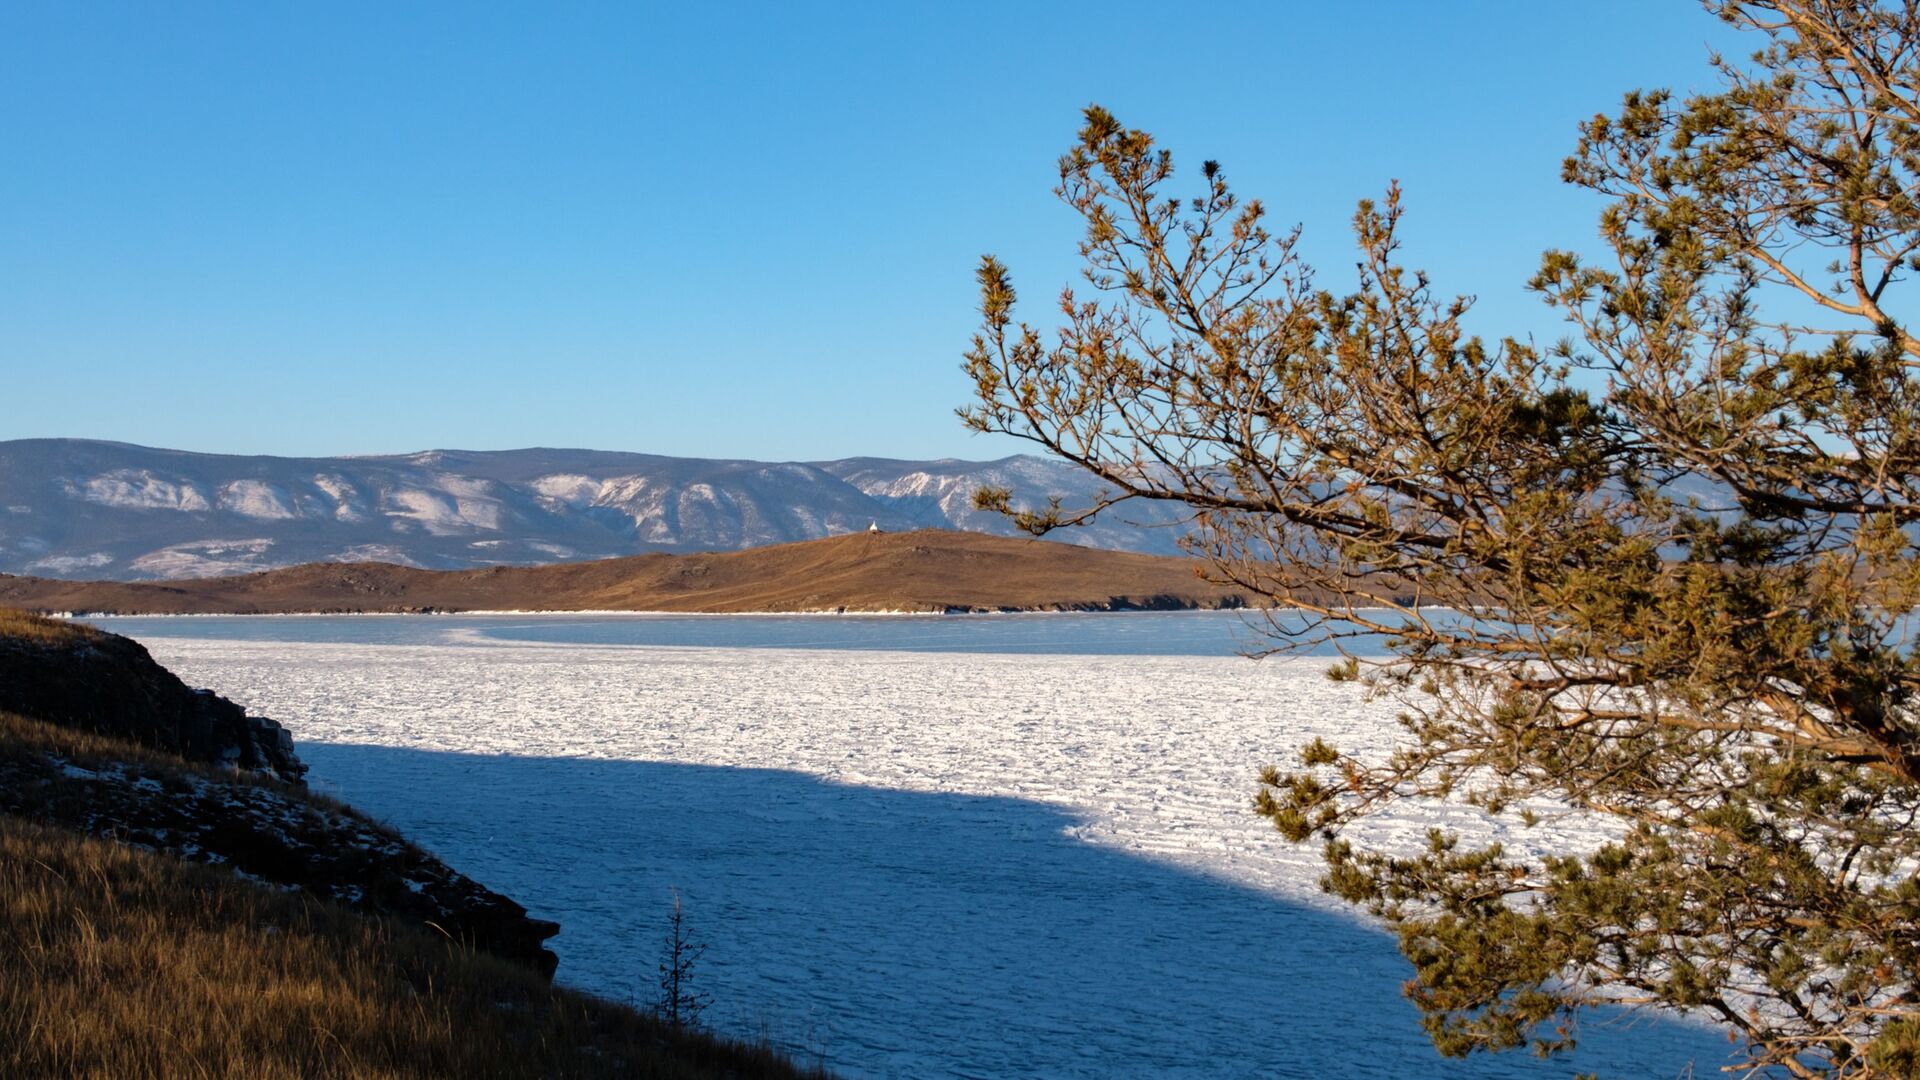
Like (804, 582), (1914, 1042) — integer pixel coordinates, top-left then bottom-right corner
(301, 744), (1728, 1078)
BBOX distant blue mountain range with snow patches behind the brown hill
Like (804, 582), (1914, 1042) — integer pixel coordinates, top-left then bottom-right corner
(0, 438), (1179, 580)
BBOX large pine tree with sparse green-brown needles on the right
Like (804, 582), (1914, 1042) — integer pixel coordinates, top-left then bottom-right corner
(962, 0), (1920, 1076)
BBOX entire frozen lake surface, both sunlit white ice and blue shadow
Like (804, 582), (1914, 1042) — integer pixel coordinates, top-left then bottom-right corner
(98, 613), (1726, 1078)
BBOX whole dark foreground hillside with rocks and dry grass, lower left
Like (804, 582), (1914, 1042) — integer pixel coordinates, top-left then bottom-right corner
(0, 611), (825, 1080)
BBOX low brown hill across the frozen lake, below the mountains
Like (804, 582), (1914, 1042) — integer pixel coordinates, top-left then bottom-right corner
(0, 530), (1246, 615)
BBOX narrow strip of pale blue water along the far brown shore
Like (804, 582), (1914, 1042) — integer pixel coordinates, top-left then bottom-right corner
(92, 611), (1382, 655)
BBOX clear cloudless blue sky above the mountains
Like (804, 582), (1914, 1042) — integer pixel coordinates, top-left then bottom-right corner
(0, 0), (1751, 459)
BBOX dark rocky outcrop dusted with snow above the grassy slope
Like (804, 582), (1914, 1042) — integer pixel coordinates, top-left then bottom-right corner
(0, 611), (561, 978)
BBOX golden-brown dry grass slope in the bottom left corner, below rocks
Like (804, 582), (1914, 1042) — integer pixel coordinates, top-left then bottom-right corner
(0, 815), (817, 1078)
